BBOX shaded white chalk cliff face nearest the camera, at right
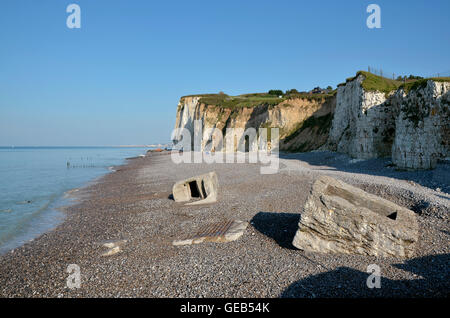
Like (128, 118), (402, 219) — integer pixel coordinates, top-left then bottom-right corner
(327, 75), (450, 169)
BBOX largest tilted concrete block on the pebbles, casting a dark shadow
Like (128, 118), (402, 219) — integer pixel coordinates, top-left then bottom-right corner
(292, 176), (418, 257)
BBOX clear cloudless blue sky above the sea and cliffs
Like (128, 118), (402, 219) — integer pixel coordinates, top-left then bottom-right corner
(0, 0), (450, 146)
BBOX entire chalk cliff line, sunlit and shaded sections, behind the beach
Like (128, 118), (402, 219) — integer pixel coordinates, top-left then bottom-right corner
(173, 72), (450, 169)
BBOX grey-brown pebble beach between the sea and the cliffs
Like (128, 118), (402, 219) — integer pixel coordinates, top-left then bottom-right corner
(0, 152), (450, 298)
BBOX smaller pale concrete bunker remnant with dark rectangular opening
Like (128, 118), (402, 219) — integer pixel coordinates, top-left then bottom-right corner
(172, 171), (219, 205)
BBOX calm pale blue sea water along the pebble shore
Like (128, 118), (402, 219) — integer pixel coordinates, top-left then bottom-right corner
(0, 147), (151, 254)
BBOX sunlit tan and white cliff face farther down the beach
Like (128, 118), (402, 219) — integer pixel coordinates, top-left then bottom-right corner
(173, 96), (336, 151)
